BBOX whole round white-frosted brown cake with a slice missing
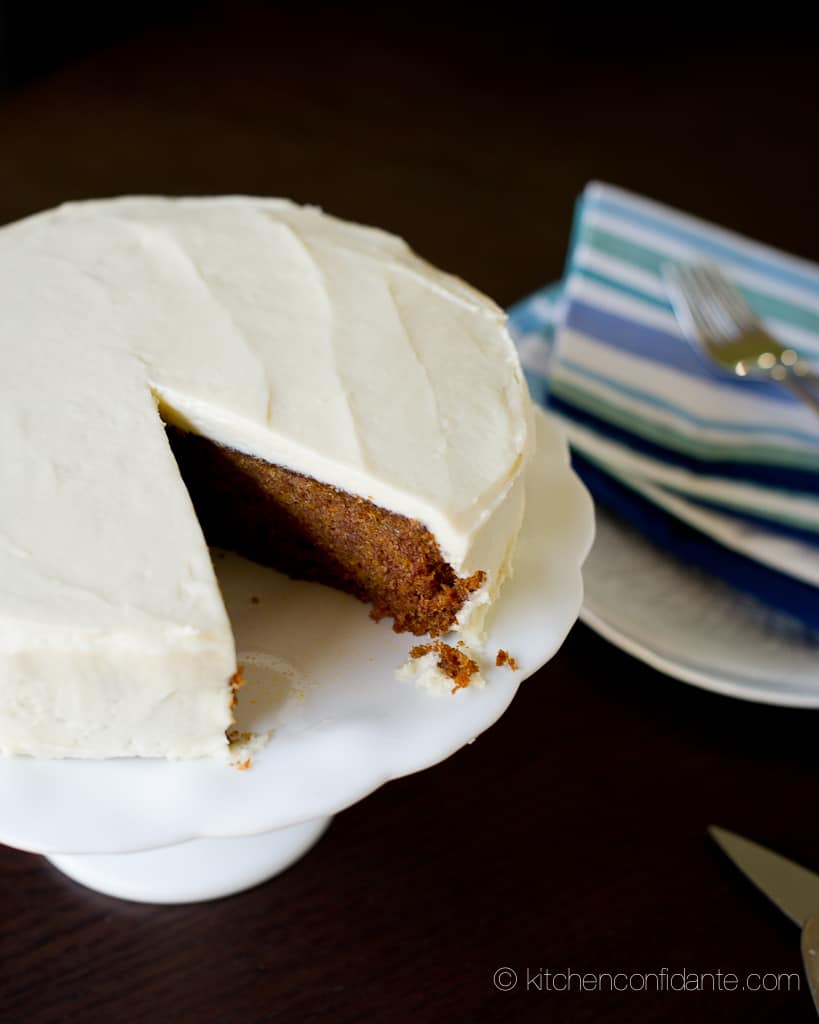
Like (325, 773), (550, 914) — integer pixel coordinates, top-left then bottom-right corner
(0, 197), (532, 758)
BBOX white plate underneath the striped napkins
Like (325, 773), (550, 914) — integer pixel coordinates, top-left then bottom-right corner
(580, 507), (819, 708)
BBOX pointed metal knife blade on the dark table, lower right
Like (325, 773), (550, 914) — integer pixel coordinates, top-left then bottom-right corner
(708, 825), (819, 927)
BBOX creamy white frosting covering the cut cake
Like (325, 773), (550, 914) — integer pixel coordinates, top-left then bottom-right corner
(0, 198), (530, 756)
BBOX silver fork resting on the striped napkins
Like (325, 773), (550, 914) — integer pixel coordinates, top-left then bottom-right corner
(662, 263), (819, 413)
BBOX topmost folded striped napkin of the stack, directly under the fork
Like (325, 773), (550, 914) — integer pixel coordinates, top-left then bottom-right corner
(512, 184), (819, 534)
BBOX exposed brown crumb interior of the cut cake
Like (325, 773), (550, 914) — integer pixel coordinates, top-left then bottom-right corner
(167, 426), (485, 636)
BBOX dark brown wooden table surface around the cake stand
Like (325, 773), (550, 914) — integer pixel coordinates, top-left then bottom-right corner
(0, 5), (819, 1024)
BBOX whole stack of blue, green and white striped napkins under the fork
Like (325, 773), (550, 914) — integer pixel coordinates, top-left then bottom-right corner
(510, 183), (819, 627)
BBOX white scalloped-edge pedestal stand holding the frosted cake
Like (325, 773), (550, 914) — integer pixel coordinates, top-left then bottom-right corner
(0, 413), (594, 903)
